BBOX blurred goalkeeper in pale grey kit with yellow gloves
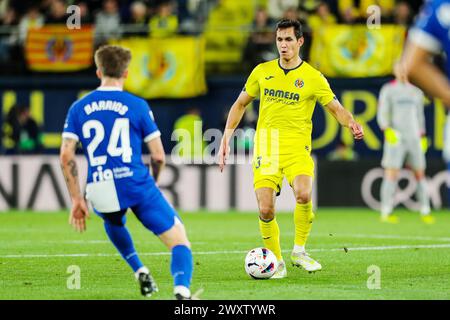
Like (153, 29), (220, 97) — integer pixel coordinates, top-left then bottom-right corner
(377, 63), (434, 223)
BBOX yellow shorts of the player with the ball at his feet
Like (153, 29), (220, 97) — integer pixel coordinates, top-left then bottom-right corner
(252, 152), (314, 194)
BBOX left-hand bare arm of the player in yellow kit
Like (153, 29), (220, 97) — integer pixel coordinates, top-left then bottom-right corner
(219, 91), (254, 171)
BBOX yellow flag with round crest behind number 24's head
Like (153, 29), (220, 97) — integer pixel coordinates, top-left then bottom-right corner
(112, 37), (206, 99)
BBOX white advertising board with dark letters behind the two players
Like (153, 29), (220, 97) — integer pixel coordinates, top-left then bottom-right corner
(0, 156), (316, 214)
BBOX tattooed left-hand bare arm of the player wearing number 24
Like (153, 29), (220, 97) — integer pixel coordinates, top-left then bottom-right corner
(59, 138), (89, 232)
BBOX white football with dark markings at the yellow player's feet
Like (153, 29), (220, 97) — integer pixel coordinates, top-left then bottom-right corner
(245, 248), (278, 279)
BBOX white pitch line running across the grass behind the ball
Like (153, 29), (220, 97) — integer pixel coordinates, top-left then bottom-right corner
(0, 243), (450, 259)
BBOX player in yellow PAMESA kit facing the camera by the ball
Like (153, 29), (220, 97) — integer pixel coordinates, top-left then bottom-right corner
(219, 19), (364, 278)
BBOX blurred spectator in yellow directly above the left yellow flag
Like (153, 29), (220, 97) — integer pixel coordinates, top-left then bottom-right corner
(149, 1), (178, 38)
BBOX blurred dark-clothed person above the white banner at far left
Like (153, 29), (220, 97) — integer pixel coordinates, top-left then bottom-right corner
(4, 105), (42, 154)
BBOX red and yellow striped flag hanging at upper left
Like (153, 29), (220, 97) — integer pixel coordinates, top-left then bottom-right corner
(25, 25), (94, 72)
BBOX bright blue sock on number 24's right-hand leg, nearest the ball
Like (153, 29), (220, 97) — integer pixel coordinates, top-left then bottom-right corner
(170, 245), (193, 288)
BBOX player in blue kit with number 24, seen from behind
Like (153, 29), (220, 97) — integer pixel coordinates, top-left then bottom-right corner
(60, 46), (193, 299)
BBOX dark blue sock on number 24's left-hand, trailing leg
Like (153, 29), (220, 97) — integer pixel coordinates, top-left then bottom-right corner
(104, 214), (144, 272)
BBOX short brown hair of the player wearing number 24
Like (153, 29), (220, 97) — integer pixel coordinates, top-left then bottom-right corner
(94, 45), (131, 79)
